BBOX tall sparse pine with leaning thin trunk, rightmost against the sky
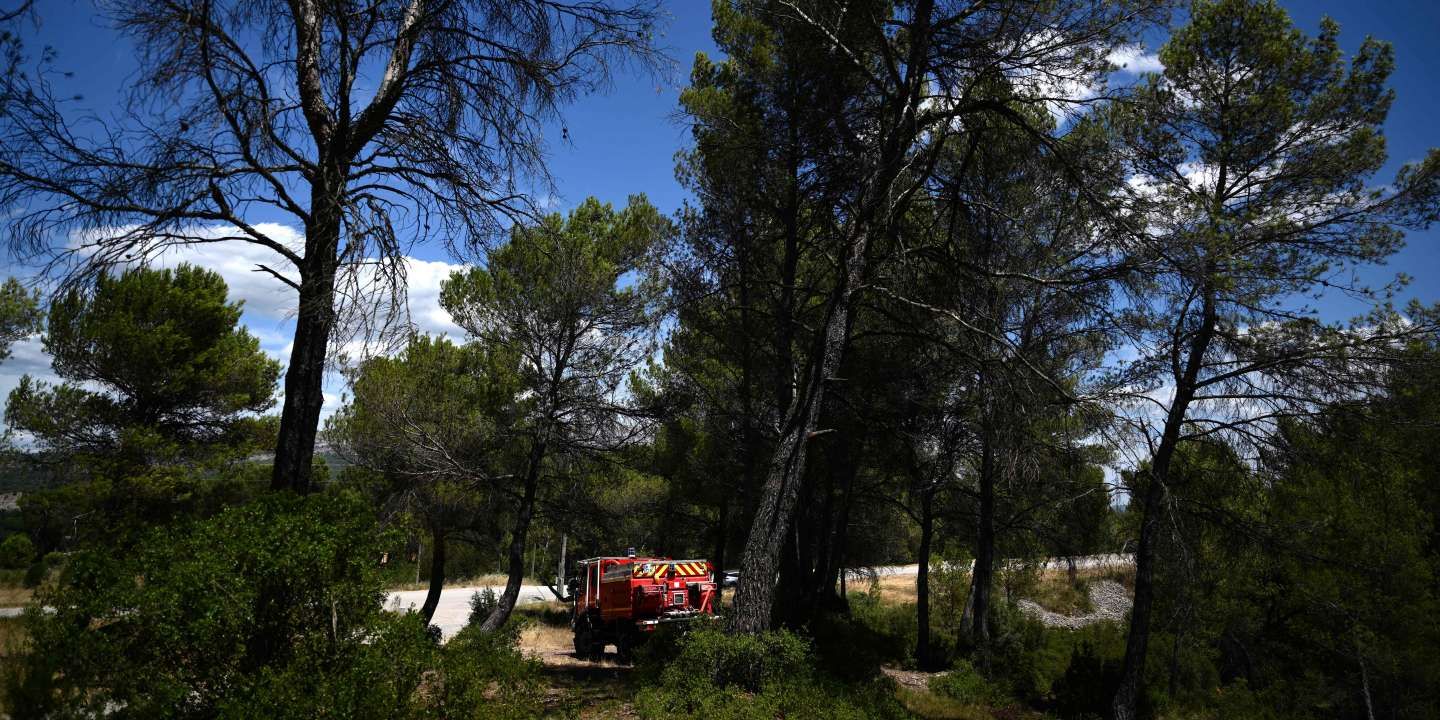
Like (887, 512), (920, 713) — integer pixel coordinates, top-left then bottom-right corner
(1113, 0), (1440, 720)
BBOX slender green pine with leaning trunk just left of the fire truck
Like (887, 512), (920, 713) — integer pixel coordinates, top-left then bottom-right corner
(441, 196), (671, 631)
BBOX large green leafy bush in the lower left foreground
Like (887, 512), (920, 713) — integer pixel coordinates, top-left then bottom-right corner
(9, 494), (536, 719)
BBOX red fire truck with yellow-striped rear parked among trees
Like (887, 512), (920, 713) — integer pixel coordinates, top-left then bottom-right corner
(570, 554), (716, 660)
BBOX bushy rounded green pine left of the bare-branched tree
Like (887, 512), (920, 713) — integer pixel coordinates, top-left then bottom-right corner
(6, 265), (279, 471)
